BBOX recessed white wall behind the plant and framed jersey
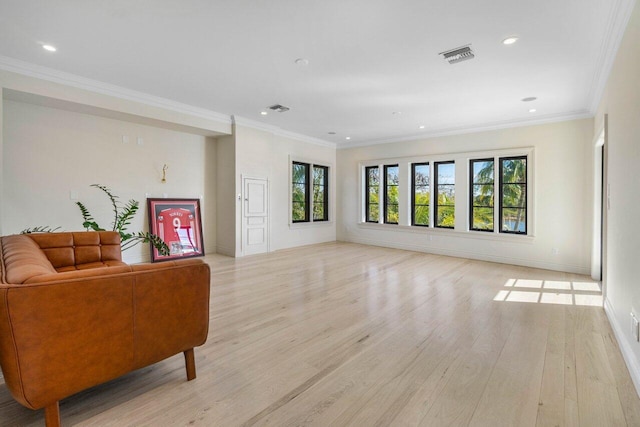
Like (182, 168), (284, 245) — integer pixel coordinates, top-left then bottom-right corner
(0, 100), (216, 262)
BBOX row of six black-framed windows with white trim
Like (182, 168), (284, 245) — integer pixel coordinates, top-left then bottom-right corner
(360, 147), (535, 240)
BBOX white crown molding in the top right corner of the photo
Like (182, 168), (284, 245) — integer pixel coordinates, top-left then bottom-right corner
(587, 0), (636, 114)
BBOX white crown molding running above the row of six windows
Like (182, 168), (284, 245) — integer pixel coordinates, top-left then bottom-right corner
(338, 110), (593, 150)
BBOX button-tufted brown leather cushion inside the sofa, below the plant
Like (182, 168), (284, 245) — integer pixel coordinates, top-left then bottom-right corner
(28, 231), (123, 272)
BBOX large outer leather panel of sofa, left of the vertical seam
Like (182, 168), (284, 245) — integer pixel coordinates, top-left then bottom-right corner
(0, 273), (135, 409)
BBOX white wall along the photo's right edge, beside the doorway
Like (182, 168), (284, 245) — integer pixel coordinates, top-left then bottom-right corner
(595, 0), (640, 391)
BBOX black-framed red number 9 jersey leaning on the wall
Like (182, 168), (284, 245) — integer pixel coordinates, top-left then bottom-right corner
(147, 199), (204, 262)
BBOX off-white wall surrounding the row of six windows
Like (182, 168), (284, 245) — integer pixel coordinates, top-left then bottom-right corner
(337, 119), (593, 274)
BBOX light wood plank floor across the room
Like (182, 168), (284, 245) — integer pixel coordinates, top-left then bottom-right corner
(0, 243), (640, 427)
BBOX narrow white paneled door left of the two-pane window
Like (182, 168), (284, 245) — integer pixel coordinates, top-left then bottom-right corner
(242, 178), (269, 255)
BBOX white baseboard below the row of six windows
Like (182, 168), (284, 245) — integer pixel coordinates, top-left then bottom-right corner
(347, 234), (591, 275)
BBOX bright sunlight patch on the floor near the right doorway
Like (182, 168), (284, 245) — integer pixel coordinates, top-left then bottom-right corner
(493, 279), (602, 307)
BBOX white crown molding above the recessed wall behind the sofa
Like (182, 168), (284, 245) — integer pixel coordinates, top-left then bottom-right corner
(0, 55), (231, 124)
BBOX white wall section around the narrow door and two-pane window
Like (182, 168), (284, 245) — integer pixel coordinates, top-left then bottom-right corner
(235, 125), (337, 255)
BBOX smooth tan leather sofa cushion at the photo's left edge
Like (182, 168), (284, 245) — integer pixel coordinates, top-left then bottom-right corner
(2, 235), (56, 284)
